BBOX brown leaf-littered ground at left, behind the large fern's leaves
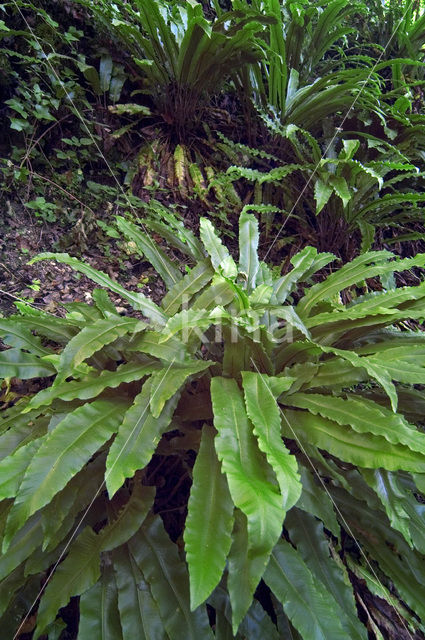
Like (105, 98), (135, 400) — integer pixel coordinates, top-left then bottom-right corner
(0, 202), (165, 315)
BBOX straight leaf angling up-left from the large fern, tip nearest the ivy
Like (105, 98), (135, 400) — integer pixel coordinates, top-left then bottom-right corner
(117, 216), (182, 289)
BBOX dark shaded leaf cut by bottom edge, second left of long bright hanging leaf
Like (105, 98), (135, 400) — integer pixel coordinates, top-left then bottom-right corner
(112, 534), (168, 640)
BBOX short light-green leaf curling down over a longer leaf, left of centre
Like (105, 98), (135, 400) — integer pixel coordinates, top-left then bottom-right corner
(150, 360), (214, 418)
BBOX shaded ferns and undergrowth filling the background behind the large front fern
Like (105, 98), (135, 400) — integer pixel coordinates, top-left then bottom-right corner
(2, 0), (424, 257)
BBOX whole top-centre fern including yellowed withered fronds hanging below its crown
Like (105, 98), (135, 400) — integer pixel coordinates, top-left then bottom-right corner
(80, 0), (273, 201)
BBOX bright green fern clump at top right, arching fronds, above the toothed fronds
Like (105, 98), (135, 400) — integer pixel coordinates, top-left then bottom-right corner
(235, 0), (380, 133)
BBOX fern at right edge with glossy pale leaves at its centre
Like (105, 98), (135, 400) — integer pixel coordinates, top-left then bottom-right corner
(220, 122), (425, 255)
